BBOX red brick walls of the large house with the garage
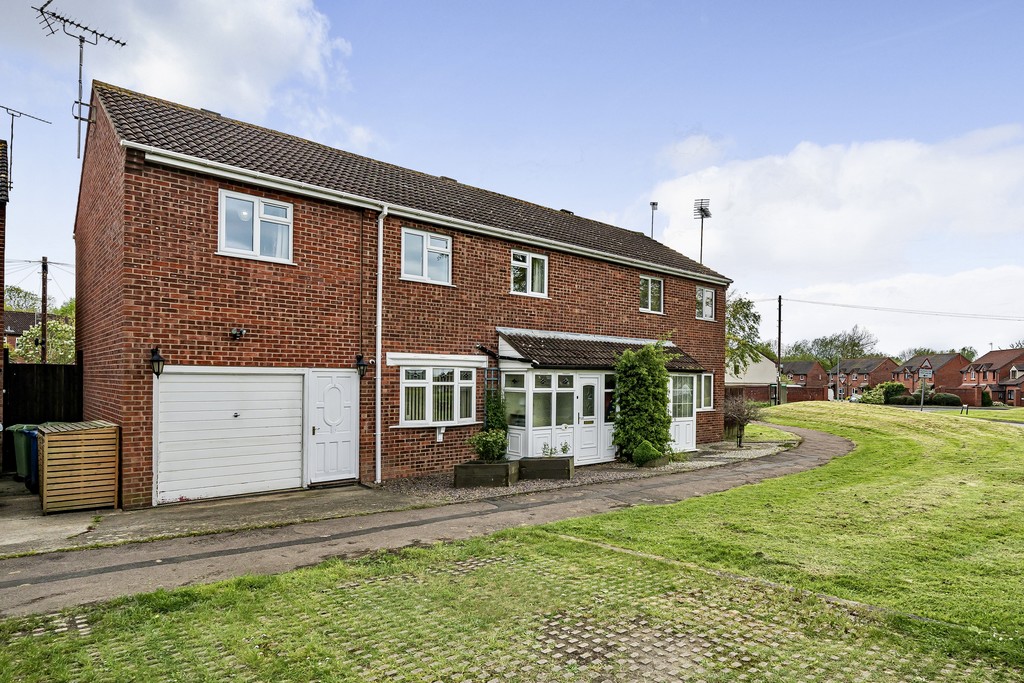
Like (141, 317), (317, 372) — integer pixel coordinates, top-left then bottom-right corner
(77, 104), (725, 508)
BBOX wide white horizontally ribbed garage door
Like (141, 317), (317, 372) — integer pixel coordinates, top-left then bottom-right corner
(157, 373), (302, 503)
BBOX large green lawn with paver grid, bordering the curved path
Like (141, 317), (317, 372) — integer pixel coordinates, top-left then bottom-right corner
(0, 402), (1024, 683)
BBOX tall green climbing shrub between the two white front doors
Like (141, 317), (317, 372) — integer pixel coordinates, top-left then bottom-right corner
(612, 341), (672, 460)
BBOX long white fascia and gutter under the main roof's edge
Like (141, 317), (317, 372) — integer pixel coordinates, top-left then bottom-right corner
(132, 140), (732, 286)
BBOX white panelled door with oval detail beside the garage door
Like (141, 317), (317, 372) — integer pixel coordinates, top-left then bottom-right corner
(308, 370), (359, 483)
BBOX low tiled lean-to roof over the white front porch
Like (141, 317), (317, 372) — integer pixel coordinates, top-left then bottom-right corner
(498, 328), (703, 373)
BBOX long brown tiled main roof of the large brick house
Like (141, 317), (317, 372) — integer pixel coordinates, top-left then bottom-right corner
(93, 82), (729, 282)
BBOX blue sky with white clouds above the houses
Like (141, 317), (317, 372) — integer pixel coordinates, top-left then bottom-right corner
(0, 0), (1024, 354)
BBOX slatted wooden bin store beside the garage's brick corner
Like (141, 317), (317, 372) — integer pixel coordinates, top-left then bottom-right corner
(39, 420), (121, 514)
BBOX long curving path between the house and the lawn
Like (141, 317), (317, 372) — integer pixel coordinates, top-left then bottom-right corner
(0, 427), (853, 616)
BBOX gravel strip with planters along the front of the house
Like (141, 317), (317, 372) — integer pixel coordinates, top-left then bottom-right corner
(381, 441), (795, 504)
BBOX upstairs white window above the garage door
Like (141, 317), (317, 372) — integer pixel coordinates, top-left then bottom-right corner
(217, 189), (293, 263)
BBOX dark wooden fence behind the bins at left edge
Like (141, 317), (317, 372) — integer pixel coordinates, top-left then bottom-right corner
(3, 349), (82, 472)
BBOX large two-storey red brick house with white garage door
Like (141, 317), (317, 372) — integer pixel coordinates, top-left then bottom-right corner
(75, 83), (730, 508)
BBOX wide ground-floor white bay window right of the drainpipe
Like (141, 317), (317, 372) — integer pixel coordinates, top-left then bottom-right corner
(400, 366), (476, 426)
